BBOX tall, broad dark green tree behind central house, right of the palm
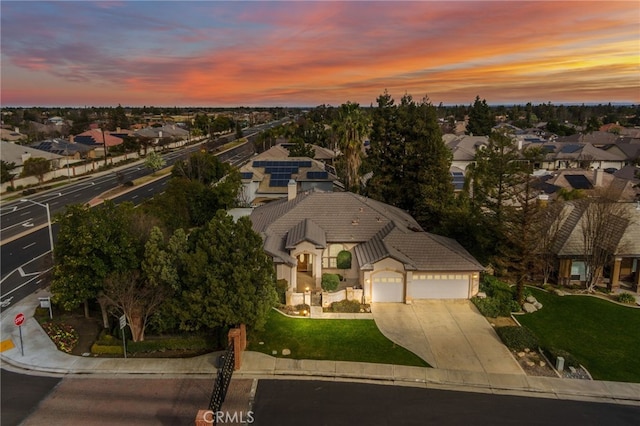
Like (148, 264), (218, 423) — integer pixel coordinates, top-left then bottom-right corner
(366, 92), (453, 229)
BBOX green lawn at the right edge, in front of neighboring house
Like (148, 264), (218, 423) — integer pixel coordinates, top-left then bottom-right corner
(518, 289), (640, 383)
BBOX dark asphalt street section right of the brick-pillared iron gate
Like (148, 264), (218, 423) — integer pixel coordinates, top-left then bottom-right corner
(253, 380), (640, 426)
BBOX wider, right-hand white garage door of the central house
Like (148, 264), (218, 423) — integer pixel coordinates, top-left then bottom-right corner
(409, 274), (469, 299)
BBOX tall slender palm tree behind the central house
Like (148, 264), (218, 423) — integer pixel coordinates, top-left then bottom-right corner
(333, 102), (369, 189)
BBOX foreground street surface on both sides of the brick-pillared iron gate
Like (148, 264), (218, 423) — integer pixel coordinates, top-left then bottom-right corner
(1, 376), (640, 426)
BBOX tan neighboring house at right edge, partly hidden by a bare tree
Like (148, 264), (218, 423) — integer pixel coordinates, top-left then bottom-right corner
(552, 202), (640, 293)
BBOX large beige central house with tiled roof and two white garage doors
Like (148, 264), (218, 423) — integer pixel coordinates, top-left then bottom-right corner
(251, 189), (484, 303)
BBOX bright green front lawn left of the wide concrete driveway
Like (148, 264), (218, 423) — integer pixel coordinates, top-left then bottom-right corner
(248, 310), (429, 367)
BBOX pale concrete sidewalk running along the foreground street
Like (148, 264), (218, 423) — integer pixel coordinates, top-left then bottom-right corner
(0, 292), (640, 406)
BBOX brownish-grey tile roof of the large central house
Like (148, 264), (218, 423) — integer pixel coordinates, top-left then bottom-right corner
(251, 190), (483, 271)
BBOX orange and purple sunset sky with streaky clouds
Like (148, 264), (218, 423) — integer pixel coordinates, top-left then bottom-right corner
(0, 0), (640, 106)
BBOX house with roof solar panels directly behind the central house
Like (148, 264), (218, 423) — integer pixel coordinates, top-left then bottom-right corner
(240, 145), (338, 206)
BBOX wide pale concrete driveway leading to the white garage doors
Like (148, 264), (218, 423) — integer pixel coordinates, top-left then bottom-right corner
(371, 300), (524, 374)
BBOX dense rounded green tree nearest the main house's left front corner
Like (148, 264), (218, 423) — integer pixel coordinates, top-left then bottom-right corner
(171, 211), (277, 330)
